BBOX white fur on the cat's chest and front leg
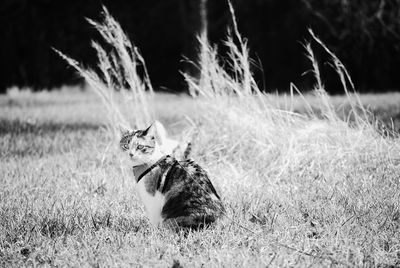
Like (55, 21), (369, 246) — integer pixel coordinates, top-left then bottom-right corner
(136, 178), (165, 226)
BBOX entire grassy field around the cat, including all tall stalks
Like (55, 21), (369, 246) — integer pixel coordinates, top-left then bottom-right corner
(0, 7), (400, 267)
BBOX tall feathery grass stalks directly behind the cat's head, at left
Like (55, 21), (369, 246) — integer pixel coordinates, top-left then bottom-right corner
(55, 7), (154, 138)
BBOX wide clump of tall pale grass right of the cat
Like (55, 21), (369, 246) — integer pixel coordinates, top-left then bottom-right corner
(185, 3), (398, 176)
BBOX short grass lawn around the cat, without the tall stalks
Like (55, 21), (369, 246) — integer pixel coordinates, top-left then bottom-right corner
(0, 89), (400, 267)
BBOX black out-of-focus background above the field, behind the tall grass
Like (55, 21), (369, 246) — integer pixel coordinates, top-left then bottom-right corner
(0, 0), (400, 93)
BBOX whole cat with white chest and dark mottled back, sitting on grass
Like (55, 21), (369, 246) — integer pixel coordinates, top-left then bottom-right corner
(120, 123), (224, 229)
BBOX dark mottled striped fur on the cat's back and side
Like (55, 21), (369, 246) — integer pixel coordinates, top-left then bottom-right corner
(135, 156), (224, 228)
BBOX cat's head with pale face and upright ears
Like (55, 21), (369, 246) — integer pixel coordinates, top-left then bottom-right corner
(120, 124), (162, 166)
